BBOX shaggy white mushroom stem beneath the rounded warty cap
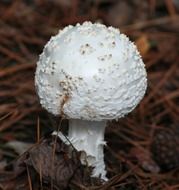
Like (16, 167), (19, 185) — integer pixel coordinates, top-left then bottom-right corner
(68, 119), (107, 180)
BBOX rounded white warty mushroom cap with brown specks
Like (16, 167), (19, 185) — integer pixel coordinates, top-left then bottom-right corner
(35, 22), (147, 121)
